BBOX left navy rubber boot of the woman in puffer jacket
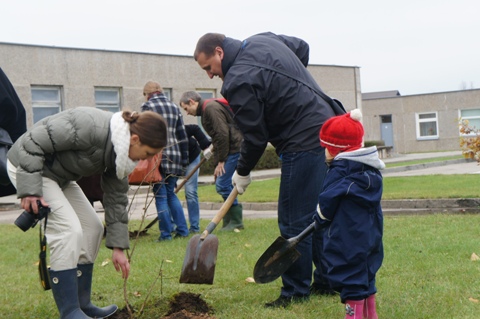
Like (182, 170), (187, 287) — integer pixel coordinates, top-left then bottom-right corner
(49, 268), (91, 319)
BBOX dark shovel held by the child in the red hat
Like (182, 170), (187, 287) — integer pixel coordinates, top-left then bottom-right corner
(253, 222), (315, 284)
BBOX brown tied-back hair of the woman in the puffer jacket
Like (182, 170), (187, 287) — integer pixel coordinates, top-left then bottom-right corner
(122, 111), (167, 148)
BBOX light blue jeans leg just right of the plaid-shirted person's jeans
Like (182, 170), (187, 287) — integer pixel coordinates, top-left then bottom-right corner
(185, 155), (200, 233)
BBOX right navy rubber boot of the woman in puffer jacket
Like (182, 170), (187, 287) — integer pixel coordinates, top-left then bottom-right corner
(77, 264), (118, 318)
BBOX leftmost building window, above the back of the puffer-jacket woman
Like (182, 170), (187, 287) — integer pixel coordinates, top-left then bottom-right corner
(31, 86), (62, 123)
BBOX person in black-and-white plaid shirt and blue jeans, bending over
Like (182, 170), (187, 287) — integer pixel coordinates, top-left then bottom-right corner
(142, 81), (188, 241)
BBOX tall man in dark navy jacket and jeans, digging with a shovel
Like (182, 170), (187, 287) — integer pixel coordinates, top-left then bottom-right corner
(194, 32), (335, 307)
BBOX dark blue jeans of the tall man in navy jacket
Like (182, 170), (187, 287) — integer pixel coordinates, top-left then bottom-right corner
(278, 146), (327, 296)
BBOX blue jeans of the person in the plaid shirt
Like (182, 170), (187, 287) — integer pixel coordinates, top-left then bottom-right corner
(153, 174), (188, 240)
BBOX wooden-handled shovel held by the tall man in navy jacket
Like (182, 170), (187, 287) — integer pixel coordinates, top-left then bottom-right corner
(180, 187), (238, 285)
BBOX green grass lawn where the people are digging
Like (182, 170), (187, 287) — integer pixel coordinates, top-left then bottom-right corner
(0, 214), (480, 319)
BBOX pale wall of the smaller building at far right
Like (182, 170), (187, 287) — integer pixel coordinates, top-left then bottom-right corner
(362, 89), (480, 153)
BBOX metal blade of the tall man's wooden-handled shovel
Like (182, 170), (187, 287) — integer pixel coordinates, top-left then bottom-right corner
(180, 234), (218, 285)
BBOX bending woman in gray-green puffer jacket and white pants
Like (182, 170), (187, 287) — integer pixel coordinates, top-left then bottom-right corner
(7, 107), (167, 318)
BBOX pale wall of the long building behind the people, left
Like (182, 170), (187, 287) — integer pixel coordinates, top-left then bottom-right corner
(0, 42), (361, 126)
